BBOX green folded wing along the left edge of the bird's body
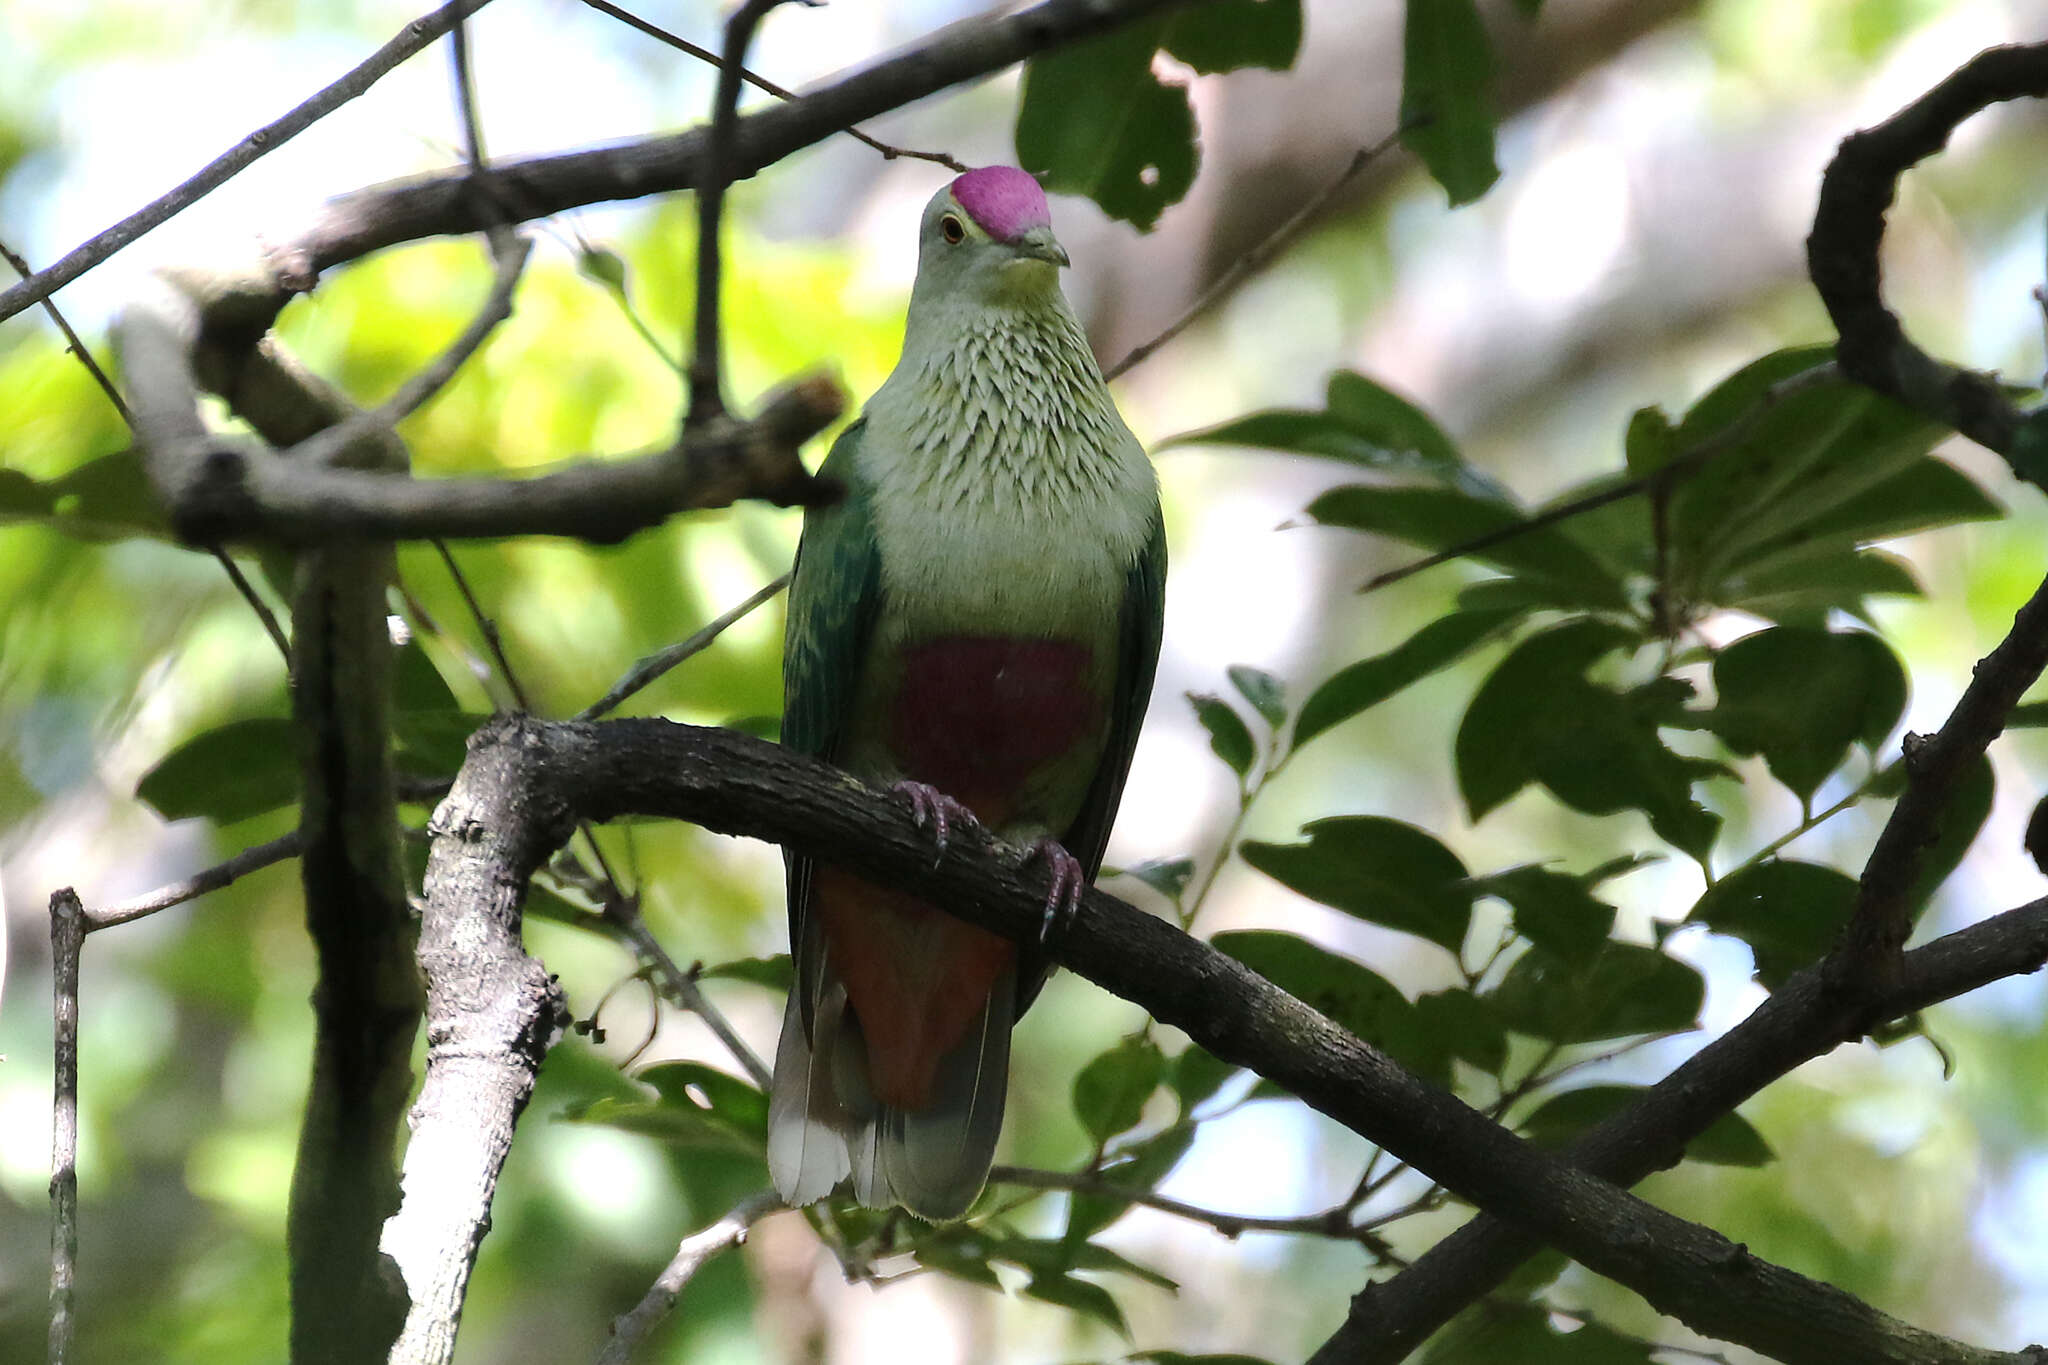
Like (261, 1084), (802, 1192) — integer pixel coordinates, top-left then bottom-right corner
(782, 417), (881, 1002)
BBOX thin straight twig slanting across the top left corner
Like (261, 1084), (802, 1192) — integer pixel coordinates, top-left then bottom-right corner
(0, 0), (489, 321)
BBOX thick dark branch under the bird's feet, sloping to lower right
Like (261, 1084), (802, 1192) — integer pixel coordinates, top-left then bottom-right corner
(395, 716), (2030, 1365)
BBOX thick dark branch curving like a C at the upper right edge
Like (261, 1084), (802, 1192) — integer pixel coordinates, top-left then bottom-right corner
(1806, 43), (2048, 464)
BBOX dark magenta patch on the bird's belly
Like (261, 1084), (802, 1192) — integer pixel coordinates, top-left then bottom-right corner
(889, 634), (1102, 821)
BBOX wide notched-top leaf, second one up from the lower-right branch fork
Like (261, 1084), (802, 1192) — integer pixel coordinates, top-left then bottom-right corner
(1487, 939), (1706, 1044)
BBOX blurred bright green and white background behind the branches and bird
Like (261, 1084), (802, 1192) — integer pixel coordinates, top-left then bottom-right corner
(0, 0), (2048, 1365)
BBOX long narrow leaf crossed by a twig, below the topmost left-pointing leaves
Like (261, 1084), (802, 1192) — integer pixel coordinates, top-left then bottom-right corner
(1307, 483), (1628, 610)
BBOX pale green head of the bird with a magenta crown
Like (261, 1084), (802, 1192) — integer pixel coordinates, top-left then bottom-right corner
(915, 166), (1067, 307)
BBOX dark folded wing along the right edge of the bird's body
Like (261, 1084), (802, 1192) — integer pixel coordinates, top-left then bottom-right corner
(1018, 505), (1165, 1015)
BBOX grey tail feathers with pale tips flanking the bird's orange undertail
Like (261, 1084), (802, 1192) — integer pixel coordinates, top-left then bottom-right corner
(768, 949), (1016, 1222)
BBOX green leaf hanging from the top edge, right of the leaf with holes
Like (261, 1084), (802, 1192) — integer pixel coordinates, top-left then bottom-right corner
(1401, 0), (1501, 207)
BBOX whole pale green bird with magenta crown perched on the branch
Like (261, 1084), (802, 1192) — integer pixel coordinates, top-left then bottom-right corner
(768, 166), (1165, 1222)
